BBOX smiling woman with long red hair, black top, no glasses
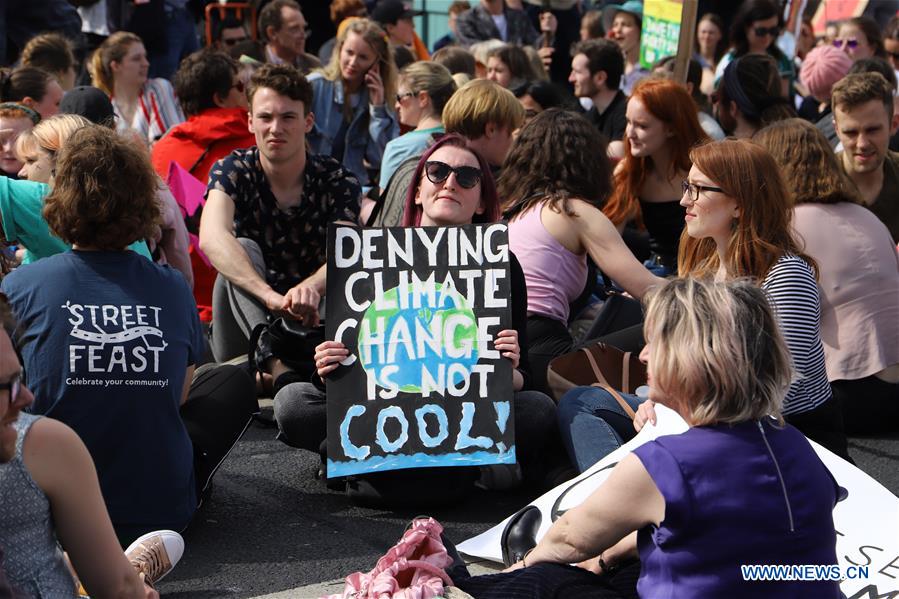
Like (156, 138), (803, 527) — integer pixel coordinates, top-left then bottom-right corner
(603, 79), (707, 276)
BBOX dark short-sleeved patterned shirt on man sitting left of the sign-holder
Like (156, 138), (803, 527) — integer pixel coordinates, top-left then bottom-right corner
(206, 146), (362, 293)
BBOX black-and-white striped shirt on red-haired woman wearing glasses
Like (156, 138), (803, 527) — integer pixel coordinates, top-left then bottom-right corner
(762, 254), (831, 415)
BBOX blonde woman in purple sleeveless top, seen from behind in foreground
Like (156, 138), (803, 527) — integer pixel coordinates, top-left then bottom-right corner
(454, 279), (841, 599)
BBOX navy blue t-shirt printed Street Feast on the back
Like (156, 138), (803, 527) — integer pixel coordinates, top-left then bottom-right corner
(0, 251), (204, 530)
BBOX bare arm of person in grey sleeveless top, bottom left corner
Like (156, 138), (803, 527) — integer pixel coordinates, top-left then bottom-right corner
(23, 418), (147, 599)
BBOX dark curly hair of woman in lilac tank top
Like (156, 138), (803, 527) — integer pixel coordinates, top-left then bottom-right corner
(497, 108), (612, 219)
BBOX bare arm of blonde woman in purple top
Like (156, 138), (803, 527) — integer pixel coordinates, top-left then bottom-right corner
(522, 454), (665, 566)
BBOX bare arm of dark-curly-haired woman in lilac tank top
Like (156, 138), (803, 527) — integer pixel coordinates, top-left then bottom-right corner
(568, 200), (665, 299)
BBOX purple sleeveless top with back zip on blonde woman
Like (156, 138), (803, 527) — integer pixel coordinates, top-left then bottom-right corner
(634, 420), (841, 599)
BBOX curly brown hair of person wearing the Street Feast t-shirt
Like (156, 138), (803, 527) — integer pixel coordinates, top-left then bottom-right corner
(43, 125), (160, 251)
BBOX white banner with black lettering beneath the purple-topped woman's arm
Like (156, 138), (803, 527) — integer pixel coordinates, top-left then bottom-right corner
(457, 404), (899, 599)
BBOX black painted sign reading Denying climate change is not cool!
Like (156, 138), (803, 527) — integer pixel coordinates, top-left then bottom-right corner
(326, 223), (515, 477)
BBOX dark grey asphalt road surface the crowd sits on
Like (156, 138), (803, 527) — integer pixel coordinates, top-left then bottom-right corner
(159, 408), (899, 599)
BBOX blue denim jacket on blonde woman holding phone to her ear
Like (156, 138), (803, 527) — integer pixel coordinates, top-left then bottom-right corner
(306, 73), (400, 187)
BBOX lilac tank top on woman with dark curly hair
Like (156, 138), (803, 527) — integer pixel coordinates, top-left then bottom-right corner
(509, 202), (587, 322)
